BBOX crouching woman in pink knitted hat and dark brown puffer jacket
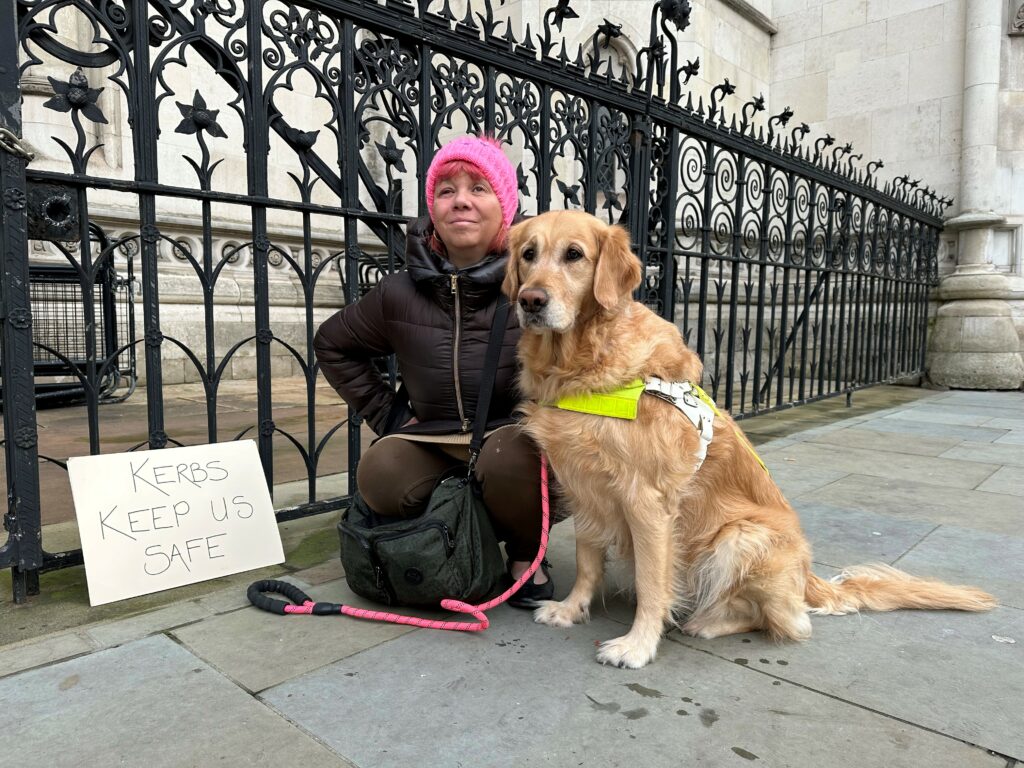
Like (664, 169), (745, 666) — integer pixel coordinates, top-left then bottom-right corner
(314, 136), (554, 608)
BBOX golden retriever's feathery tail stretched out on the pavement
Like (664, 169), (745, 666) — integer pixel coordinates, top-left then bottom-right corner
(804, 563), (996, 615)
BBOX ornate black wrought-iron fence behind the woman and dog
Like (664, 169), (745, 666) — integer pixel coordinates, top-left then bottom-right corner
(0, 0), (950, 600)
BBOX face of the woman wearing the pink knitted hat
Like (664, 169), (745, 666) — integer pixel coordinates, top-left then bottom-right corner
(432, 171), (502, 268)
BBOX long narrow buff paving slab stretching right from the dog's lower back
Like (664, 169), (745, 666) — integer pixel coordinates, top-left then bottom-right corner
(775, 442), (999, 488)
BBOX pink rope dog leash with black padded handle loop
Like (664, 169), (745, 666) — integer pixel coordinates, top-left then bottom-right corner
(246, 454), (550, 632)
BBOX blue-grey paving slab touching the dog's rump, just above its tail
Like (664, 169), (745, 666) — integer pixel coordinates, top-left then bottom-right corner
(793, 501), (936, 568)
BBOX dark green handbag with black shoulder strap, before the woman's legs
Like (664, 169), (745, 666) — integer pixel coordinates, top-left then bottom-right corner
(338, 303), (508, 605)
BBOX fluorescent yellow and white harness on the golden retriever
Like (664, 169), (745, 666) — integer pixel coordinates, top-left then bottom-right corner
(555, 376), (768, 472)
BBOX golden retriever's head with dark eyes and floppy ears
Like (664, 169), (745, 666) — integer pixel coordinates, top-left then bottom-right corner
(502, 211), (640, 333)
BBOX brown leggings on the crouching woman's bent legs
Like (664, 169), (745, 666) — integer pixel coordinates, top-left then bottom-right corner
(355, 425), (541, 560)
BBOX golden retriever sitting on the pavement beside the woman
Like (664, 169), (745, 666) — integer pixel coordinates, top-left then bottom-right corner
(503, 211), (995, 668)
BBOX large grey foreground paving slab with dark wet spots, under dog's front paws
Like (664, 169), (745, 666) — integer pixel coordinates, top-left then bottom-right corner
(263, 610), (1005, 768)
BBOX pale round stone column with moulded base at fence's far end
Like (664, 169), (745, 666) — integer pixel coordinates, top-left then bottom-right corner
(928, 0), (1024, 389)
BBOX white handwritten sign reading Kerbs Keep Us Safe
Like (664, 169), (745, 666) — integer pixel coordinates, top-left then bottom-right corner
(68, 440), (285, 605)
